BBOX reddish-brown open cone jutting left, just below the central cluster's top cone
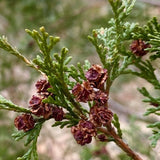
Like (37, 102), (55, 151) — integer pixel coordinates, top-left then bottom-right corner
(72, 81), (93, 102)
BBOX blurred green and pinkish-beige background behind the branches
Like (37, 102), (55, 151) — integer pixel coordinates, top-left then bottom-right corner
(0, 0), (160, 160)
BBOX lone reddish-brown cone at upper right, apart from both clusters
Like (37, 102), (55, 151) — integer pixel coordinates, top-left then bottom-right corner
(130, 39), (151, 57)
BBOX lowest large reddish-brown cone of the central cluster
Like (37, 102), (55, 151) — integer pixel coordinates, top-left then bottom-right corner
(71, 120), (96, 145)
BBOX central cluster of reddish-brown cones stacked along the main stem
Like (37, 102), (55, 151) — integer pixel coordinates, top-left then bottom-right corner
(71, 65), (113, 145)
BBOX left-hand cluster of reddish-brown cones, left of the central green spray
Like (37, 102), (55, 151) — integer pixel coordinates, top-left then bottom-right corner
(14, 79), (64, 132)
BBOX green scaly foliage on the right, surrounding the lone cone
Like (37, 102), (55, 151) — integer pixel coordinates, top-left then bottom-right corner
(89, 0), (160, 154)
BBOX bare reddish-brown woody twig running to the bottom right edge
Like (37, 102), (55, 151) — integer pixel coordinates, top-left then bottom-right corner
(98, 124), (143, 160)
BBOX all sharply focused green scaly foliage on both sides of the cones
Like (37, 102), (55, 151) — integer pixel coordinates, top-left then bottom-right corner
(0, 0), (160, 160)
